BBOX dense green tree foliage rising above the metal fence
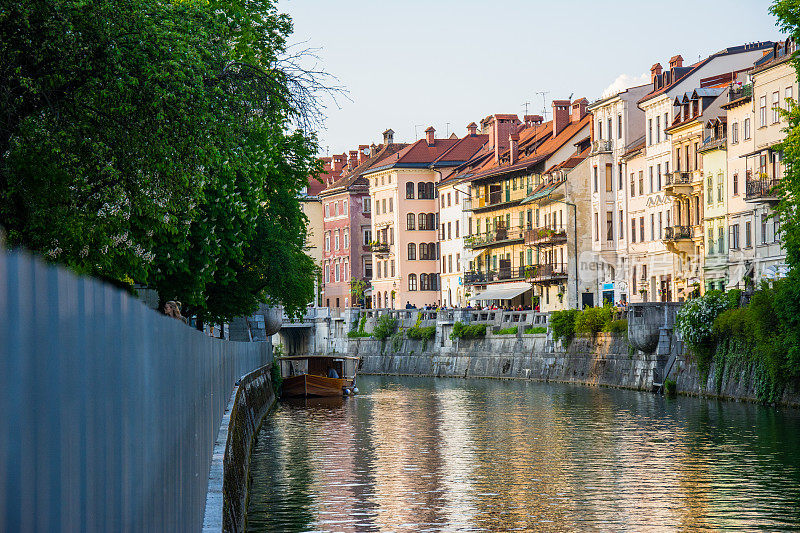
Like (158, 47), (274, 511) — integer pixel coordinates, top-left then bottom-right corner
(0, 0), (321, 320)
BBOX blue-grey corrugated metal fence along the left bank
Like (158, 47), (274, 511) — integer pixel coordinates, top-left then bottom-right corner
(0, 251), (271, 532)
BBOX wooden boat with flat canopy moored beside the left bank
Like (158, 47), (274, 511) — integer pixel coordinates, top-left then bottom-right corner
(278, 355), (359, 398)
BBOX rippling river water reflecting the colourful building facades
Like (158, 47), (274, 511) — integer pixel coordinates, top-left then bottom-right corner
(248, 376), (800, 531)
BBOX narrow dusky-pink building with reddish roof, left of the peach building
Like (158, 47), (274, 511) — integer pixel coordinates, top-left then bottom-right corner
(319, 137), (406, 309)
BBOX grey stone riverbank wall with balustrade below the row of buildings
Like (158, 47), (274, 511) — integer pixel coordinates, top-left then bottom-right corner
(280, 303), (800, 407)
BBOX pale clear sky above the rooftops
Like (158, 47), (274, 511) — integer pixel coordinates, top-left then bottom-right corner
(278, 0), (781, 155)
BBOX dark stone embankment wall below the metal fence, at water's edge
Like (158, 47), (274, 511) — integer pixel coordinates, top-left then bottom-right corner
(222, 365), (275, 532)
